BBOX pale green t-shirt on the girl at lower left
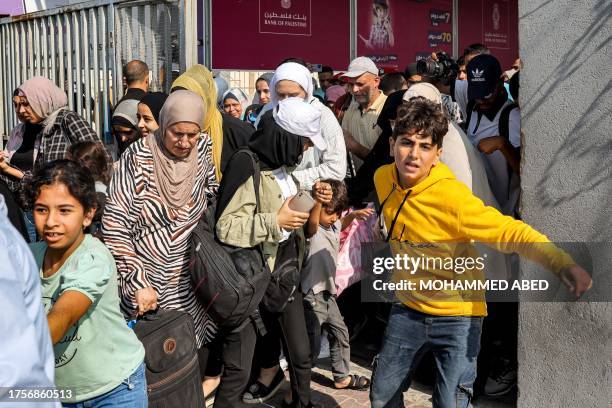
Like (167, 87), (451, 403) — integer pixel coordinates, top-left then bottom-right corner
(30, 235), (144, 402)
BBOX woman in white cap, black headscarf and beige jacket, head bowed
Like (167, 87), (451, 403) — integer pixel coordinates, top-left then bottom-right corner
(215, 98), (331, 407)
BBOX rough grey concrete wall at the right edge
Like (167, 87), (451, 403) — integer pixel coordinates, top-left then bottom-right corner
(518, 0), (612, 408)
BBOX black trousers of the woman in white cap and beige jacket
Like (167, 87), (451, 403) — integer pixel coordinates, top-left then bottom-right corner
(257, 289), (312, 407)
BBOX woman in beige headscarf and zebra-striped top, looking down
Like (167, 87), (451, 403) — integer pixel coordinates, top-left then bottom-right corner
(102, 90), (218, 382)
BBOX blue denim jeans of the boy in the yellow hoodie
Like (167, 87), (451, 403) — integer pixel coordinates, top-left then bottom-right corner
(370, 305), (482, 408)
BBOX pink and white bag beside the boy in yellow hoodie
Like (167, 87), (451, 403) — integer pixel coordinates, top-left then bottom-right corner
(336, 203), (376, 296)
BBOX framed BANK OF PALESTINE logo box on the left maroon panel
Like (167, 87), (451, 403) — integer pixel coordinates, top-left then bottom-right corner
(259, 0), (312, 37)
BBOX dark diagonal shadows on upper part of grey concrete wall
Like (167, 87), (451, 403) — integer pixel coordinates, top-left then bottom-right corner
(520, 0), (612, 239)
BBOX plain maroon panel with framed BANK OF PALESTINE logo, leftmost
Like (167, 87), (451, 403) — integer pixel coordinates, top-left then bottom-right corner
(211, 0), (351, 71)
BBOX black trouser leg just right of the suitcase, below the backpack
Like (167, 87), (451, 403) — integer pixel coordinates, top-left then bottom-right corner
(200, 322), (257, 408)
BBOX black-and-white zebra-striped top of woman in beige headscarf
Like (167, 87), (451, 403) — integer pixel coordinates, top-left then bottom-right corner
(102, 134), (218, 347)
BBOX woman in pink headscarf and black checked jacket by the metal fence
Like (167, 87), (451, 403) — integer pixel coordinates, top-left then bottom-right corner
(0, 76), (100, 181)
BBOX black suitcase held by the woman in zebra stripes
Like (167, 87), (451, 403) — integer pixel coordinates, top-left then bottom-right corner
(134, 309), (204, 408)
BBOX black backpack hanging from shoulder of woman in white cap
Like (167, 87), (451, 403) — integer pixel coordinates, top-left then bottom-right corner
(190, 149), (270, 331)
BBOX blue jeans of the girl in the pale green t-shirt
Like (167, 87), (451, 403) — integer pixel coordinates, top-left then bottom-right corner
(62, 362), (149, 408)
